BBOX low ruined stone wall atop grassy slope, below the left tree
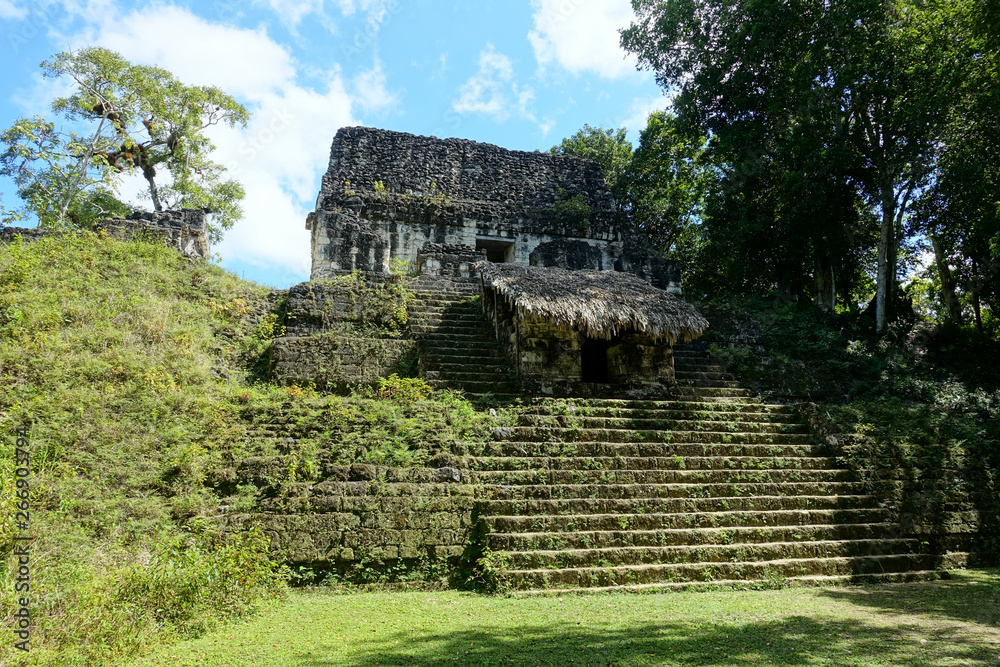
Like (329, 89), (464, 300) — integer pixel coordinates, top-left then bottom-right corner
(0, 209), (211, 259)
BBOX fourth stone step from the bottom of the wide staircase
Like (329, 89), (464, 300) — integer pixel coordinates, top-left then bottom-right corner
(484, 506), (890, 534)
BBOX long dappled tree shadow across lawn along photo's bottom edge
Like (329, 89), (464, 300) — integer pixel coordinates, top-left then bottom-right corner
(288, 616), (997, 667)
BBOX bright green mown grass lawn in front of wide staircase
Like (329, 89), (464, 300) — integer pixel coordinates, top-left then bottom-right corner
(130, 570), (1000, 667)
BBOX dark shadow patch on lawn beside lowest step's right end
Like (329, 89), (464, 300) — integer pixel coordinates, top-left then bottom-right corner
(821, 570), (1000, 628)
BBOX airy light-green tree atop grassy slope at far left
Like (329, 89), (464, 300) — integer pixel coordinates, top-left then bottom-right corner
(0, 48), (249, 236)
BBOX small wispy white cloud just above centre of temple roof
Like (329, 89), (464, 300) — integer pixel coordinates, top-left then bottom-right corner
(452, 44), (535, 122)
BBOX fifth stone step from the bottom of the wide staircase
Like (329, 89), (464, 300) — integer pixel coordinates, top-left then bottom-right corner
(481, 482), (875, 520)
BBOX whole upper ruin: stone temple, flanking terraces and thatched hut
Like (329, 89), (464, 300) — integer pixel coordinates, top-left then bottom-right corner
(273, 127), (707, 395)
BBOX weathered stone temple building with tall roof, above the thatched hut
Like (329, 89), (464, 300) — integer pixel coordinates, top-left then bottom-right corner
(306, 127), (680, 292)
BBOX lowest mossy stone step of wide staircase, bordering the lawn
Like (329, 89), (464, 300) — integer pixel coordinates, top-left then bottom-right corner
(506, 554), (972, 589)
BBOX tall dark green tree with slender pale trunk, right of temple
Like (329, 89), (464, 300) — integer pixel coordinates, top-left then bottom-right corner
(622, 0), (961, 331)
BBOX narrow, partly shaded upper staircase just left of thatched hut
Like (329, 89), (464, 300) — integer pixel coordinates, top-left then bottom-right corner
(408, 276), (518, 400)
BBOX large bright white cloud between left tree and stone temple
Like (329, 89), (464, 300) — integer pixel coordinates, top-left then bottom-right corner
(30, 0), (395, 275)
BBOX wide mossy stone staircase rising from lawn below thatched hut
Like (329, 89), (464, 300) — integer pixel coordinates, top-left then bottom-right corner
(469, 394), (963, 593)
